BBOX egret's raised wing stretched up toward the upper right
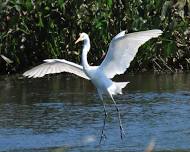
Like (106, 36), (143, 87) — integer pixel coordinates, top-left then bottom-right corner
(99, 30), (162, 78)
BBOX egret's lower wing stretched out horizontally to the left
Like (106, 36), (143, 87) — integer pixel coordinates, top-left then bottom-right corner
(23, 59), (89, 80)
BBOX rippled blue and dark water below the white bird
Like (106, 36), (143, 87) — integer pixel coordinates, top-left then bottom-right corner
(0, 74), (190, 152)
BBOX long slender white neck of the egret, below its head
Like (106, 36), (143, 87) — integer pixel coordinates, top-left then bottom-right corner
(82, 38), (90, 70)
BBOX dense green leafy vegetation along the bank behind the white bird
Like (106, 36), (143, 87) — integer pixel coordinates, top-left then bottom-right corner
(0, 0), (190, 73)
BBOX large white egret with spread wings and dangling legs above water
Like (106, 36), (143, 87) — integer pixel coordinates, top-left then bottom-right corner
(23, 29), (162, 142)
